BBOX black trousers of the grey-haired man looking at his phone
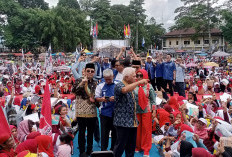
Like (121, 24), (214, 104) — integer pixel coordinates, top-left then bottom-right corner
(100, 115), (116, 151)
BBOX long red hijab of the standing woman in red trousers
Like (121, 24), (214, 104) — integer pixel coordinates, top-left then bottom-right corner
(136, 69), (149, 110)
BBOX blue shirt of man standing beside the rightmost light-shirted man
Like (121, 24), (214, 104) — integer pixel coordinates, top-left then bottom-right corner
(163, 61), (176, 80)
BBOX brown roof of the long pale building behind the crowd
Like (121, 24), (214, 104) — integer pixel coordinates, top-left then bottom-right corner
(164, 28), (222, 37)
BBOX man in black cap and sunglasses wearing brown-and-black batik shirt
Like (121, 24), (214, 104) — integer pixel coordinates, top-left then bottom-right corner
(72, 63), (98, 156)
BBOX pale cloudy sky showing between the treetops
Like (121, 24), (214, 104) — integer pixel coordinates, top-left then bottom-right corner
(45, 0), (226, 29)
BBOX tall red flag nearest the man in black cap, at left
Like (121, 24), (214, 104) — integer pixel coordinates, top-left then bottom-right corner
(39, 80), (52, 136)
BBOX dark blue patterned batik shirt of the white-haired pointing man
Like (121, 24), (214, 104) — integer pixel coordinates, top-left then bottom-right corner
(113, 82), (138, 128)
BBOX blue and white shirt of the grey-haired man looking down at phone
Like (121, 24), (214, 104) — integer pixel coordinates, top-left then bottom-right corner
(95, 81), (118, 117)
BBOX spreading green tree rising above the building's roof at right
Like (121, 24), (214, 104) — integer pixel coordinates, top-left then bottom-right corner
(170, 0), (219, 43)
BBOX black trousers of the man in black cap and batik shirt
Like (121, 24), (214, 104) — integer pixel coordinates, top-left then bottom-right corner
(77, 117), (97, 154)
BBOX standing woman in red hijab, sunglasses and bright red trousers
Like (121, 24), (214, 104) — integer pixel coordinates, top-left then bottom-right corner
(135, 69), (156, 156)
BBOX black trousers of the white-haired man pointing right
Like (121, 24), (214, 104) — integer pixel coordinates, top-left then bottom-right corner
(114, 126), (137, 157)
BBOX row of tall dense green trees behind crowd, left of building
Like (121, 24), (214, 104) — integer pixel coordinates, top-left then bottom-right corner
(0, 0), (165, 52)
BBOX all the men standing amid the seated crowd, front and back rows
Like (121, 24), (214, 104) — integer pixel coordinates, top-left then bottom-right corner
(72, 49), (185, 157)
